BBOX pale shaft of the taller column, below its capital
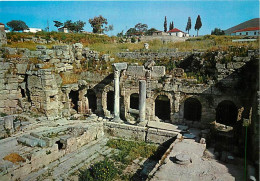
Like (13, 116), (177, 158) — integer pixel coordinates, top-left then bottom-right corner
(114, 70), (120, 120)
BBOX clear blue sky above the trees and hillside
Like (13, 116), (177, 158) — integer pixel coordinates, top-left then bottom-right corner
(0, 0), (259, 35)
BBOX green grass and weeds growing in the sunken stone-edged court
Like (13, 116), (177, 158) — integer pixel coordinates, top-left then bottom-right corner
(79, 139), (158, 181)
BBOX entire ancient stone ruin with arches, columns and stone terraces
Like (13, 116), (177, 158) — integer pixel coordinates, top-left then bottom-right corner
(0, 38), (259, 180)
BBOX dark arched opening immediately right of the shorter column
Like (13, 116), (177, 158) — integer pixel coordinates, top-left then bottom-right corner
(155, 95), (171, 120)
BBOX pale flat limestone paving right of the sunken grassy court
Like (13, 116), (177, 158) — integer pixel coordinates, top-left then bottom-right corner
(151, 139), (243, 181)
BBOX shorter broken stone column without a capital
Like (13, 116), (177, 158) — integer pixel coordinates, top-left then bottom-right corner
(139, 80), (146, 122)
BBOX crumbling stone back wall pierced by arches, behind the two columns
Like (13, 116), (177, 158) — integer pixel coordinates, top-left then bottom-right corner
(0, 43), (257, 127)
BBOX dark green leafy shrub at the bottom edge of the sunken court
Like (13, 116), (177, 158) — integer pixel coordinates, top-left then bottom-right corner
(79, 158), (118, 181)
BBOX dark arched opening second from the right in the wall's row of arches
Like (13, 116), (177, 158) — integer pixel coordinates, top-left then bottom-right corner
(184, 98), (202, 121)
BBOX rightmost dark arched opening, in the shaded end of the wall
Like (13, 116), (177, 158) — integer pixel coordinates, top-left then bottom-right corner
(216, 100), (238, 126)
